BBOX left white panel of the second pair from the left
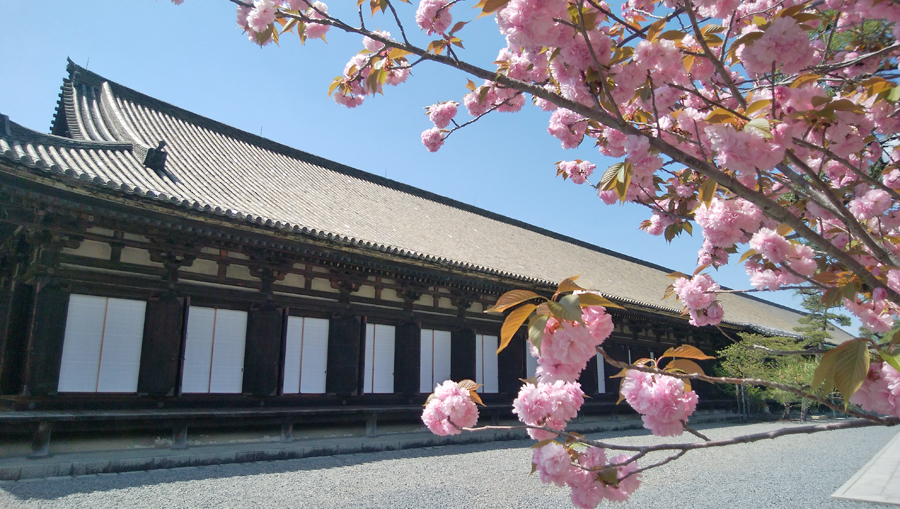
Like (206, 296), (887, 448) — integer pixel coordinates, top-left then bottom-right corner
(181, 306), (216, 393)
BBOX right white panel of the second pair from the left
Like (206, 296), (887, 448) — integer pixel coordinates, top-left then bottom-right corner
(209, 309), (247, 394)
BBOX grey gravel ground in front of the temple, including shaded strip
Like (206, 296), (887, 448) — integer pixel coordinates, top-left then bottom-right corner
(0, 424), (897, 509)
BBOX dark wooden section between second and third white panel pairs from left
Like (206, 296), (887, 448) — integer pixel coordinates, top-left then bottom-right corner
(243, 304), (284, 396)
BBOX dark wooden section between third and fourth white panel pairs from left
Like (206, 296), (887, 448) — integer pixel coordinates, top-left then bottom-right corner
(325, 315), (361, 396)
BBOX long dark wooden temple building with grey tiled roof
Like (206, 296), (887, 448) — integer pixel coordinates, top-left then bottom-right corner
(0, 62), (824, 454)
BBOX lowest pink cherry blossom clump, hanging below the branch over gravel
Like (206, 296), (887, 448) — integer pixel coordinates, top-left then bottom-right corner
(533, 442), (641, 509)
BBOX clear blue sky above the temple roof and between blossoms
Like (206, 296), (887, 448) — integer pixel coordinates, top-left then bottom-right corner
(0, 0), (836, 330)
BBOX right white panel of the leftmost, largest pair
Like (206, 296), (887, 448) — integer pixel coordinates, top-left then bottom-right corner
(97, 298), (147, 392)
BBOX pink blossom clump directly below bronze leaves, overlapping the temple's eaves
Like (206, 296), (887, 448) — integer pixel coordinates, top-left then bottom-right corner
(530, 306), (614, 382)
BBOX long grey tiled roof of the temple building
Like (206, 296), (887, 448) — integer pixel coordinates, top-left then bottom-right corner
(0, 63), (852, 342)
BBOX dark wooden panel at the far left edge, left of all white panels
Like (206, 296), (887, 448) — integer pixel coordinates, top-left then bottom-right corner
(0, 280), (34, 395)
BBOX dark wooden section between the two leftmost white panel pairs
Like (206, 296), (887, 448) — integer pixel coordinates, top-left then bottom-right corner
(138, 294), (185, 396)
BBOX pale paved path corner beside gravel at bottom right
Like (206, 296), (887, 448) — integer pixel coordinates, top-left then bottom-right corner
(832, 433), (900, 505)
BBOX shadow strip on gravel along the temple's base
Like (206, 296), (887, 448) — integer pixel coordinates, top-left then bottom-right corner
(0, 422), (735, 503)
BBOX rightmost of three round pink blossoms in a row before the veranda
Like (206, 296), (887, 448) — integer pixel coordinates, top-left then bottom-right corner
(620, 369), (699, 437)
